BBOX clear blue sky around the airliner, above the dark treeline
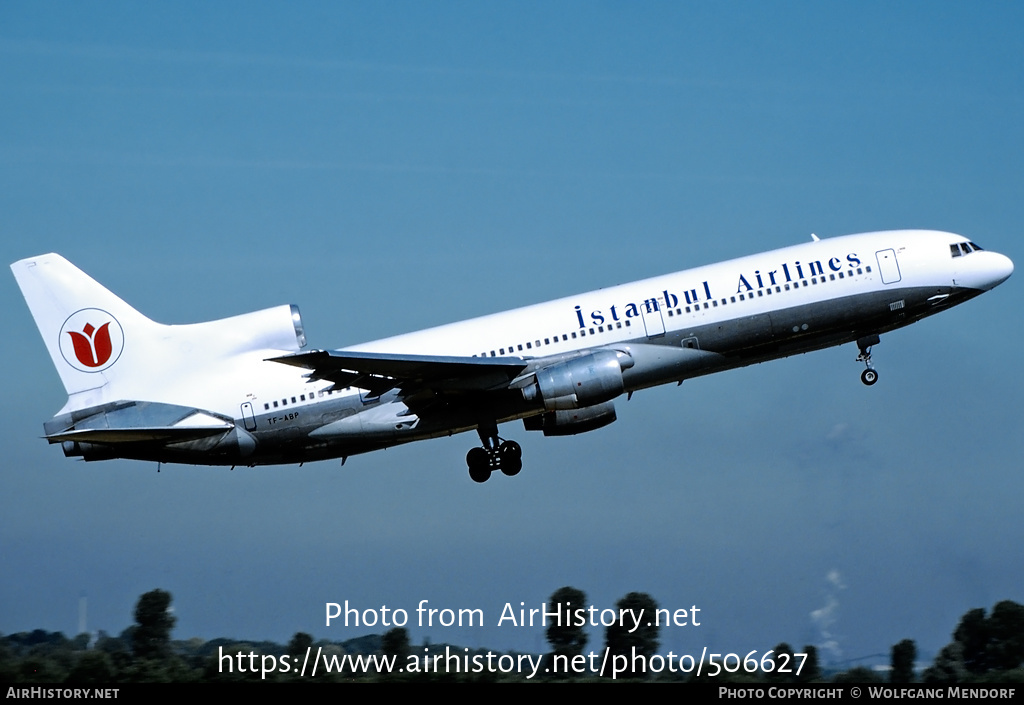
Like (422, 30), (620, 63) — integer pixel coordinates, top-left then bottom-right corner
(0, 2), (1024, 661)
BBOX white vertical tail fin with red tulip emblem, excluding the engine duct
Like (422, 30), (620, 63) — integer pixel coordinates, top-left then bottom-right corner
(10, 253), (162, 397)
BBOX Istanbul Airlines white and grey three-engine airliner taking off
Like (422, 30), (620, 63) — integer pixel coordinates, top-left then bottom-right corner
(11, 231), (1013, 483)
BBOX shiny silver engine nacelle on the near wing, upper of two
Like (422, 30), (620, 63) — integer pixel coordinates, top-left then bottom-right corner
(522, 350), (633, 409)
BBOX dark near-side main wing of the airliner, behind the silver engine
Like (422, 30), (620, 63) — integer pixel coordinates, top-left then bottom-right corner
(269, 350), (528, 399)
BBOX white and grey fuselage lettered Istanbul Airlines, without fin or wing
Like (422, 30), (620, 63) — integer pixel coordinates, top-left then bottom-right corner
(19, 231), (1013, 464)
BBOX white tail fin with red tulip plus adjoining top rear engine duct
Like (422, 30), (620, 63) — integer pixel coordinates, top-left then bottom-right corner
(10, 254), (305, 412)
